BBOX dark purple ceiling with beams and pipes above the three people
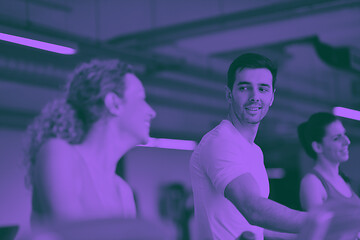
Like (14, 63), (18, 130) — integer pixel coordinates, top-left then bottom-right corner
(0, 0), (360, 168)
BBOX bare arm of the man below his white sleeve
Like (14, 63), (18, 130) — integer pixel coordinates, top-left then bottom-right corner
(224, 173), (307, 233)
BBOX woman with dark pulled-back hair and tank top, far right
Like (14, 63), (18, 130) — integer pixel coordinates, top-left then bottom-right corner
(298, 112), (359, 211)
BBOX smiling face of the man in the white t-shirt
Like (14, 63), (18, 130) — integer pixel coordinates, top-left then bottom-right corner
(227, 68), (274, 124)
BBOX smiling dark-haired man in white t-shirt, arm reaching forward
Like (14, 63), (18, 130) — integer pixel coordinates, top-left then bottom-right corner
(190, 53), (306, 240)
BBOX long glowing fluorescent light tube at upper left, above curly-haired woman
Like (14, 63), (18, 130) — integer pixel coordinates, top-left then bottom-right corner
(0, 33), (76, 55)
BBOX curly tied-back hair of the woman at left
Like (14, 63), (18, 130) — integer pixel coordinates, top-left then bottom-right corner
(24, 59), (133, 187)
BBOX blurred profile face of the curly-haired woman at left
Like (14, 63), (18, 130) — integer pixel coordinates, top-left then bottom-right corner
(120, 73), (156, 144)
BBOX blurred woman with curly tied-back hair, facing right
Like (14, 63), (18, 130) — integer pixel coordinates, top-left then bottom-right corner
(25, 60), (156, 222)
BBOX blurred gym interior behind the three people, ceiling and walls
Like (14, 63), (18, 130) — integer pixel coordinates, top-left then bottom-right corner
(0, 0), (360, 239)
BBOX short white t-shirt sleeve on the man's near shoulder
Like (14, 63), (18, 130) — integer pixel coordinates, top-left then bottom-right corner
(203, 139), (250, 194)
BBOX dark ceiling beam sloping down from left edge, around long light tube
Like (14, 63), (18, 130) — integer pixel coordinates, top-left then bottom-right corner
(0, 22), (225, 82)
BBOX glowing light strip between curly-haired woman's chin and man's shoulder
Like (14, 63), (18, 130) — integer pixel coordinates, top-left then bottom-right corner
(138, 138), (197, 150)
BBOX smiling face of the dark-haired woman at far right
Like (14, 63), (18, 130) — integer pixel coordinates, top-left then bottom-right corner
(321, 120), (350, 163)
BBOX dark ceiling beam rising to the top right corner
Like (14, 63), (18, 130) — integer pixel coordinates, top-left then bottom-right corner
(108, 0), (360, 49)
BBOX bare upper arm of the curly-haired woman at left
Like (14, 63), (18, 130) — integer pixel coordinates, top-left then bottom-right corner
(33, 139), (82, 220)
